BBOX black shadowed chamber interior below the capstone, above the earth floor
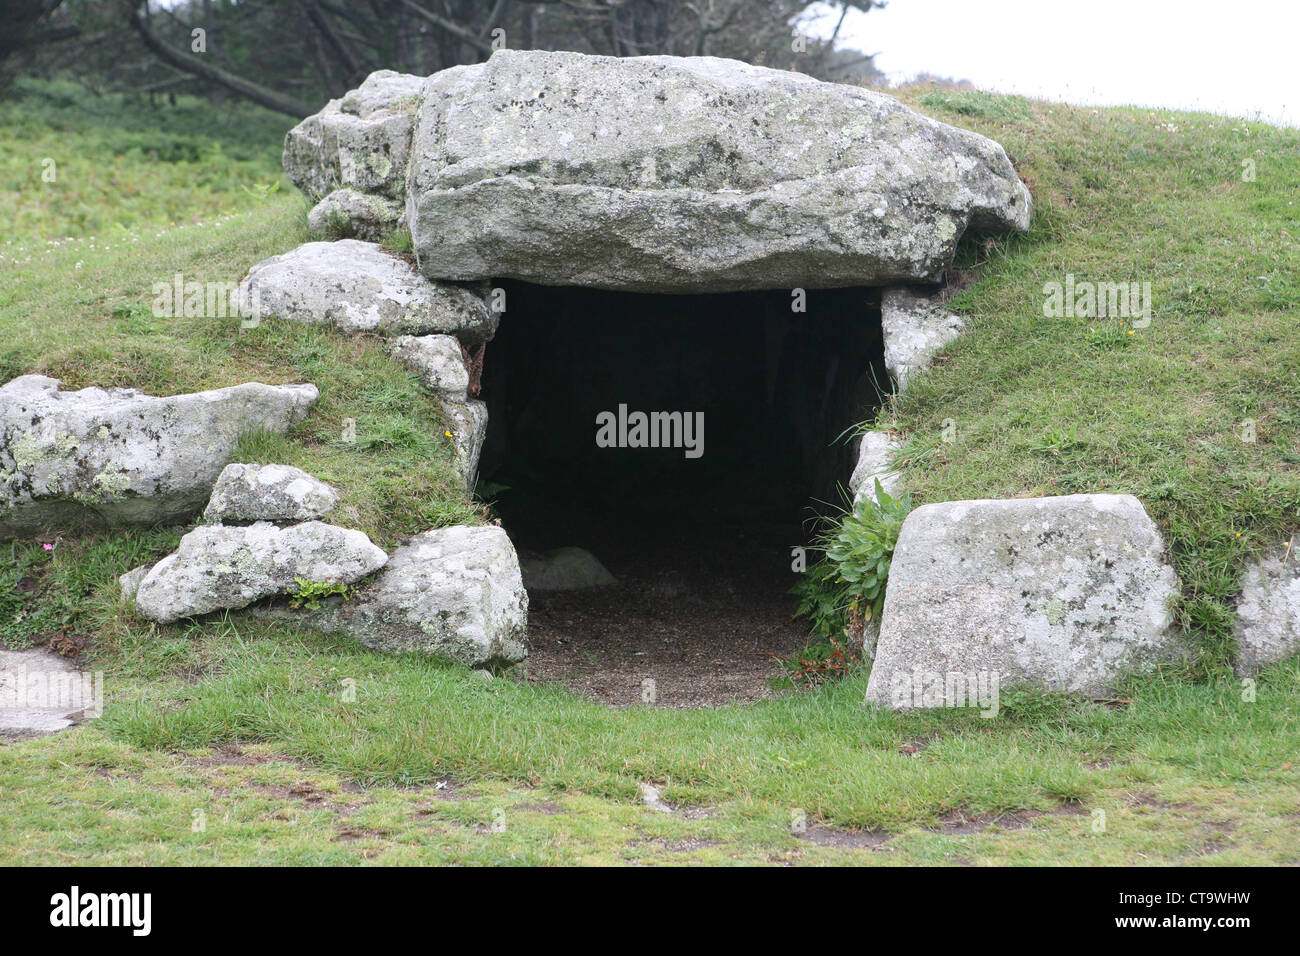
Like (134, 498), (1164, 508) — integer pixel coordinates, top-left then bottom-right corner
(480, 282), (885, 546)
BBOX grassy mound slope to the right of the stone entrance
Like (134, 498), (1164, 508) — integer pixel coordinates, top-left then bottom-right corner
(881, 91), (1300, 676)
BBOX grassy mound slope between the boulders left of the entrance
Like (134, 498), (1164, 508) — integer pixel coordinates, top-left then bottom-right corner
(0, 195), (477, 554)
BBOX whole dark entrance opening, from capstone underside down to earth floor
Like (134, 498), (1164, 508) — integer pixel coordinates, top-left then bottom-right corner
(480, 282), (888, 706)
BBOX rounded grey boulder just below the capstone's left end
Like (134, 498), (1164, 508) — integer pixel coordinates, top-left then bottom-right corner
(235, 239), (498, 341)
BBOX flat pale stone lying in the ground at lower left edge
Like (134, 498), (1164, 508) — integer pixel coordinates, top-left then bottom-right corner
(0, 649), (104, 740)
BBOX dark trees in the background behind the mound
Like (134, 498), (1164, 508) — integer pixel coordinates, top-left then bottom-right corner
(0, 0), (884, 117)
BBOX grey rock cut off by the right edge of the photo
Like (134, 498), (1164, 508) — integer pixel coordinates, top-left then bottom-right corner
(1235, 536), (1300, 678)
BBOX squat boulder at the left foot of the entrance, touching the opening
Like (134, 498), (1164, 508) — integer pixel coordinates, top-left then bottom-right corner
(330, 525), (528, 667)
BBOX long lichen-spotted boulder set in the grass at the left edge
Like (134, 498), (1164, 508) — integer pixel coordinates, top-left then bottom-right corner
(0, 375), (317, 538)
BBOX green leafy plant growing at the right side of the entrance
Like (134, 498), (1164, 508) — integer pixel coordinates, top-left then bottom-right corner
(792, 480), (911, 639)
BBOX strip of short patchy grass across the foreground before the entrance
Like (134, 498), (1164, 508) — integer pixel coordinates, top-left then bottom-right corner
(0, 618), (1300, 864)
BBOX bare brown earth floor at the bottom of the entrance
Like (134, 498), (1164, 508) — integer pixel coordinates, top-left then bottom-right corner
(524, 527), (809, 708)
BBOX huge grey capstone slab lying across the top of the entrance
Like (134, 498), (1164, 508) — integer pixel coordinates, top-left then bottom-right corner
(407, 49), (1031, 293)
